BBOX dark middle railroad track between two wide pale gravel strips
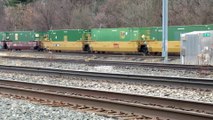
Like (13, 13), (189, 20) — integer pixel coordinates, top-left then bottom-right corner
(0, 65), (213, 89)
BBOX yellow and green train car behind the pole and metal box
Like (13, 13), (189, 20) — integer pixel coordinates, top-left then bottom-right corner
(146, 25), (213, 54)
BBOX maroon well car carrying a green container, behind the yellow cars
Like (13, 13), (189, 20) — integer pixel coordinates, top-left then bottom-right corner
(5, 31), (39, 50)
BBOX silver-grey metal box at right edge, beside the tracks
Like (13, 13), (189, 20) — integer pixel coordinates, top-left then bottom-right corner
(180, 31), (213, 65)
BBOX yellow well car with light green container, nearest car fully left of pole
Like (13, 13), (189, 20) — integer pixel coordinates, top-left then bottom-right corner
(89, 28), (148, 53)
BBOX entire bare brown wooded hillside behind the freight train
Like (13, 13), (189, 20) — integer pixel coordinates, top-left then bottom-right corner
(0, 0), (213, 31)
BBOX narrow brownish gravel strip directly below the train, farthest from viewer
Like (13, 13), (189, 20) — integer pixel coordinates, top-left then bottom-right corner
(0, 51), (181, 64)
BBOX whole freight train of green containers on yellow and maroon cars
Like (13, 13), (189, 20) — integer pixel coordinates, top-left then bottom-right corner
(0, 25), (213, 54)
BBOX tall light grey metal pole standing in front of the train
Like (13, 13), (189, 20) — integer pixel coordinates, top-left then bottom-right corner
(162, 0), (168, 63)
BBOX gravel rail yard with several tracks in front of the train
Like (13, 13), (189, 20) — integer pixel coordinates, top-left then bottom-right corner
(0, 51), (213, 120)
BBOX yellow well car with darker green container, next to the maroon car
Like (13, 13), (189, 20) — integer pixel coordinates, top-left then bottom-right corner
(42, 29), (87, 51)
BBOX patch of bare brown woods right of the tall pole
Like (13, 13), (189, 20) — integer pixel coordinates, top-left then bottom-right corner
(169, 0), (213, 25)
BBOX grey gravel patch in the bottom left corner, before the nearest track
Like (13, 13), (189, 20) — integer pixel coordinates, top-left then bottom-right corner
(0, 95), (113, 120)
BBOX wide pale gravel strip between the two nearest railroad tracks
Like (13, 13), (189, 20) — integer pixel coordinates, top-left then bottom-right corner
(0, 71), (213, 103)
